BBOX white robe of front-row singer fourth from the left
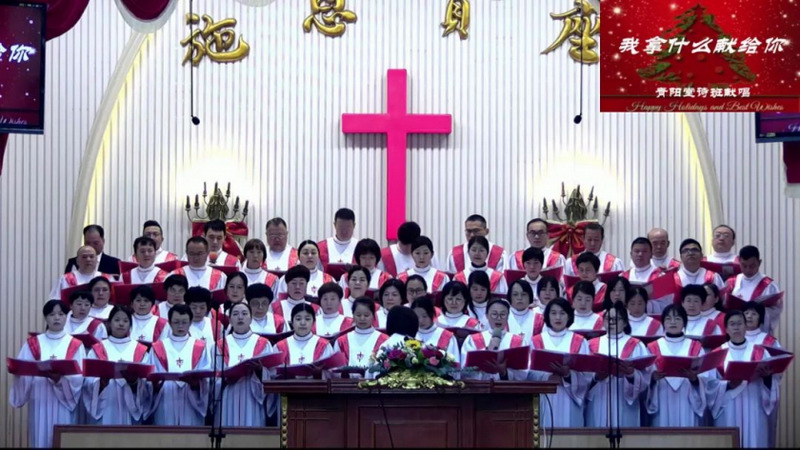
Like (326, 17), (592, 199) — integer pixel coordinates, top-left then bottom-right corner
(216, 332), (277, 427)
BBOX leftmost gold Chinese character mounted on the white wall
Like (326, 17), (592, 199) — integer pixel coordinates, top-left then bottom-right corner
(181, 14), (250, 67)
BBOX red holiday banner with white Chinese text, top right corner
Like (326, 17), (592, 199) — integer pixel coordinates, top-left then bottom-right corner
(600, 0), (800, 112)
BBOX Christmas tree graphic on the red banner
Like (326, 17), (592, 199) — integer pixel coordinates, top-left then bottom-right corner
(637, 4), (756, 88)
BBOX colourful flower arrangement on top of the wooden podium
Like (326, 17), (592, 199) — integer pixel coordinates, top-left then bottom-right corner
(369, 339), (458, 377)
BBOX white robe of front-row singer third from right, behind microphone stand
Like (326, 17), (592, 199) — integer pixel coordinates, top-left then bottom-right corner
(586, 334), (652, 428)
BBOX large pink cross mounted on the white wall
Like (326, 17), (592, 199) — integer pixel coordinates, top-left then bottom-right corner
(342, 69), (453, 240)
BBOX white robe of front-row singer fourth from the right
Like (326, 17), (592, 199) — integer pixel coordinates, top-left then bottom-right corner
(528, 327), (591, 430)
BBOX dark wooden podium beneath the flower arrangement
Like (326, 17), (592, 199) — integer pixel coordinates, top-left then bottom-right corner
(265, 379), (556, 448)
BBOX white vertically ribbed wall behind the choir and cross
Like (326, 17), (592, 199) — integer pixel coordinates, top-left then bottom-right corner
(0, 0), (800, 446)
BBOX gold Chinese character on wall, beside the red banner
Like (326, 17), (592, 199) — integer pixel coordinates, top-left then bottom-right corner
(541, 0), (600, 64)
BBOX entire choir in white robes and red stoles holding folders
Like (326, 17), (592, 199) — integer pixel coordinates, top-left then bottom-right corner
(10, 214), (783, 447)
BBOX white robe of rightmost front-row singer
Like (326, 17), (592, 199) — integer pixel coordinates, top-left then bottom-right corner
(708, 341), (780, 448)
